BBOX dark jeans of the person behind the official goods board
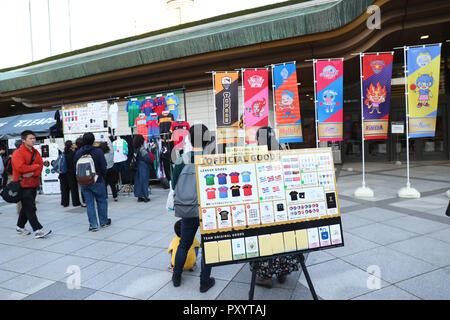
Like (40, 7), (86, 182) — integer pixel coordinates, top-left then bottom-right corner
(173, 218), (211, 281)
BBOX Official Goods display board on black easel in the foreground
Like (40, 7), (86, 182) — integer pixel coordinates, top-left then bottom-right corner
(195, 148), (344, 266)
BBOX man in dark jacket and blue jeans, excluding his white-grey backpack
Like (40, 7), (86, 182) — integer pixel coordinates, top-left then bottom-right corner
(74, 132), (111, 232)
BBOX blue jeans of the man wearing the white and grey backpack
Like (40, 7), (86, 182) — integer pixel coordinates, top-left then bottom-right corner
(81, 182), (108, 228)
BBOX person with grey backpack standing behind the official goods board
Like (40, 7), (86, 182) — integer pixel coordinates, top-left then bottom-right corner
(172, 124), (215, 292)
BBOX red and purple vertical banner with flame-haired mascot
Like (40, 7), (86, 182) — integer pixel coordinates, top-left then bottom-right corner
(362, 53), (394, 140)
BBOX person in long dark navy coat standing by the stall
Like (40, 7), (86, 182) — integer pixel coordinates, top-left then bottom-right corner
(133, 134), (152, 202)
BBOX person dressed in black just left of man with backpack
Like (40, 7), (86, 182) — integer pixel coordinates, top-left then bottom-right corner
(59, 140), (81, 207)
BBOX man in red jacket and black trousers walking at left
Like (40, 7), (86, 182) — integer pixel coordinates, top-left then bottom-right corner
(11, 130), (52, 238)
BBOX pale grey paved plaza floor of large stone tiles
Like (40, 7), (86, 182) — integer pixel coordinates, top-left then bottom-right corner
(0, 161), (450, 300)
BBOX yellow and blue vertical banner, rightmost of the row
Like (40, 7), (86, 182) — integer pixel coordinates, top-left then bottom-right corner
(406, 44), (441, 138)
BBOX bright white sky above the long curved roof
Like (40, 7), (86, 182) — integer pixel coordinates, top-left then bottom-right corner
(0, 0), (286, 69)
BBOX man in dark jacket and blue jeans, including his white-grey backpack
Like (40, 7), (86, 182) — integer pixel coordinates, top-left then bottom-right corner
(74, 132), (111, 232)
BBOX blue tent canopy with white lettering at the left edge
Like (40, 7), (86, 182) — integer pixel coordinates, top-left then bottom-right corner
(0, 110), (56, 140)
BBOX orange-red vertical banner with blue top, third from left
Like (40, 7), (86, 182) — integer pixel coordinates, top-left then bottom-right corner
(272, 62), (303, 143)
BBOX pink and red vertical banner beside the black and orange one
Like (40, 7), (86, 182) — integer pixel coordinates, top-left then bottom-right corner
(243, 69), (269, 144)
